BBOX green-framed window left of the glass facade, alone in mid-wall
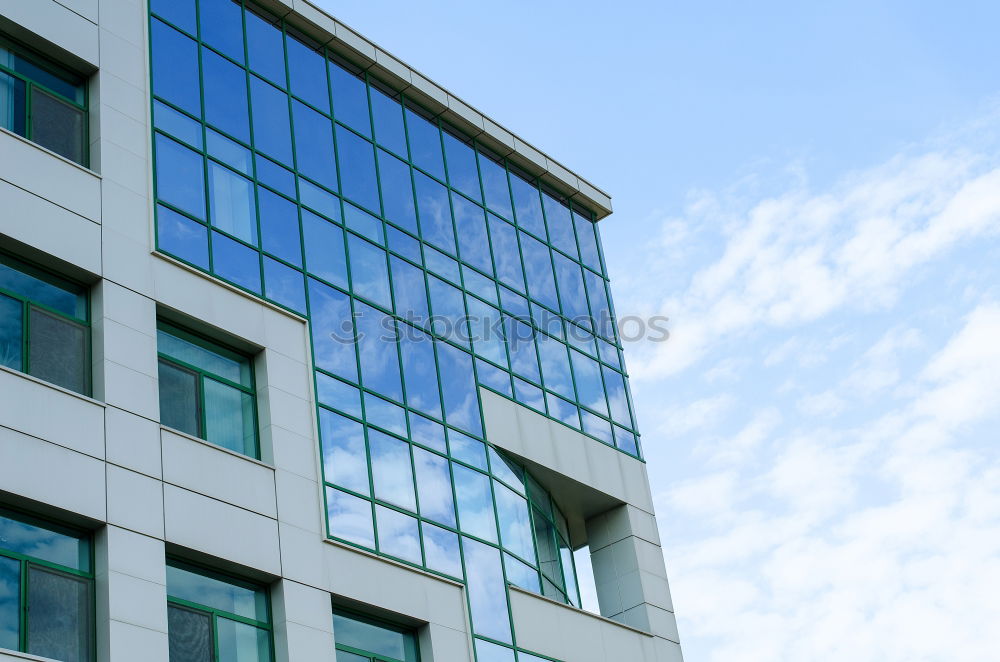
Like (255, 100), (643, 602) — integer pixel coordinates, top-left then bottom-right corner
(157, 321), (260, 459)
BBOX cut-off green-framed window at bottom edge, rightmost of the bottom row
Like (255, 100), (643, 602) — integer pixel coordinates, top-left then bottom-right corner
(333, 607), (420, 662)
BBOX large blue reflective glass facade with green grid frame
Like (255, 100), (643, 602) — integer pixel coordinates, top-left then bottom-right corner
(150, 0), (640, 660)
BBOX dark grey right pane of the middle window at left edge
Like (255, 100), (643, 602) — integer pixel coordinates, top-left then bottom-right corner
(28, 308), (89, 393)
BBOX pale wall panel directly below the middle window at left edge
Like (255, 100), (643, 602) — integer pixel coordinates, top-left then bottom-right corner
(0, 368), (104, 459)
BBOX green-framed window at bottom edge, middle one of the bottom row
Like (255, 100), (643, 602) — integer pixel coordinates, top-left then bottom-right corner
(167, 559), (273, 662)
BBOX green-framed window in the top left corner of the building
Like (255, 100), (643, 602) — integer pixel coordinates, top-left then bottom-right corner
(0, 34), (90, 167)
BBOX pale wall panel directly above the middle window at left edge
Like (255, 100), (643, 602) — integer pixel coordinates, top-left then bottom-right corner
(0, 179), (101, 274)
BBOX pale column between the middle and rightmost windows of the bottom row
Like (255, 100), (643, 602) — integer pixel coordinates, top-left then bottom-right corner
(272, 579), (337, 662)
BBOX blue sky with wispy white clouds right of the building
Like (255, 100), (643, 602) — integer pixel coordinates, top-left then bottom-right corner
(324, 0), (1000, 662)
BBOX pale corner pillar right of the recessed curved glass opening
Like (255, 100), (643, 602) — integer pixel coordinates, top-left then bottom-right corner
(587, 504), (681, 660)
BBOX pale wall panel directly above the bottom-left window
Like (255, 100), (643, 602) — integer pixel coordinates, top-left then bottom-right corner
(0, 427), (106, 521)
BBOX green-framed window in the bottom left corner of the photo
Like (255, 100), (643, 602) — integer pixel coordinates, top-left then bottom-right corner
(0, 508), (97, 662)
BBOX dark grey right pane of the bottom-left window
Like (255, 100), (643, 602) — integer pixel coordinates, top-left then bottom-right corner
(27, 566), (94, 662)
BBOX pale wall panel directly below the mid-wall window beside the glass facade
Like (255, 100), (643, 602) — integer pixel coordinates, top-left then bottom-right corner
(161, 429), (278, 518)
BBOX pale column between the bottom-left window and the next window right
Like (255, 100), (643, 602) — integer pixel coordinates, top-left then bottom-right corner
(95, 525), (170, 662)
